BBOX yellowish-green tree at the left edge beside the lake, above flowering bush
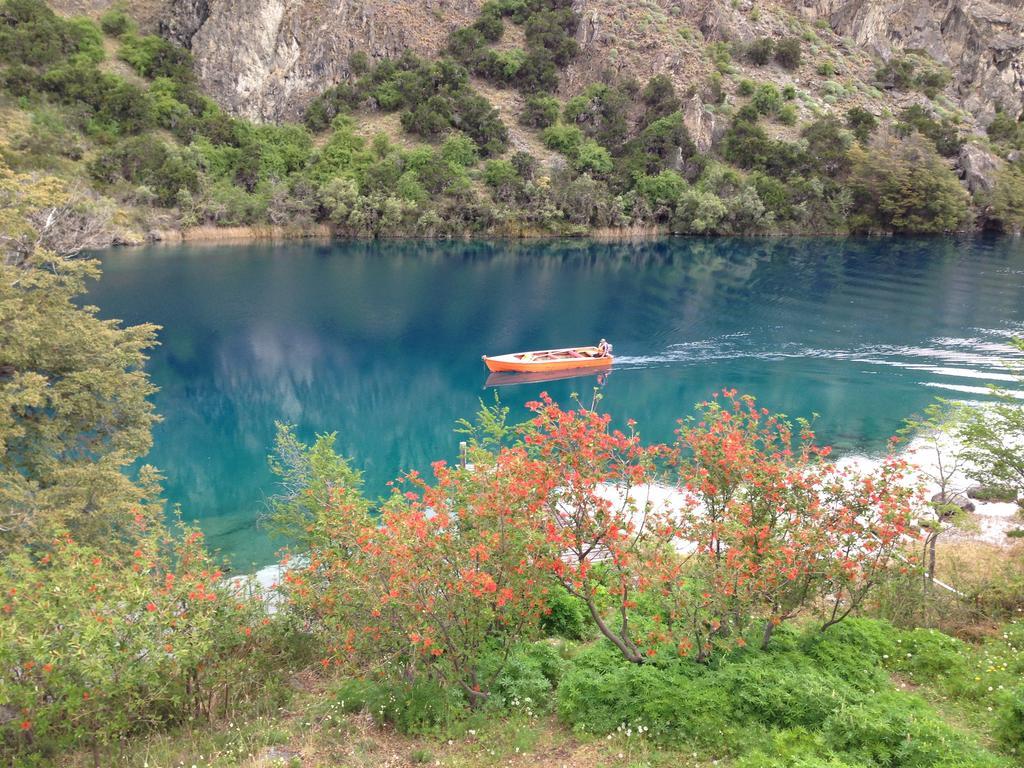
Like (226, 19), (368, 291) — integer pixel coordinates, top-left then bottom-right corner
(0, 160), (159, 552)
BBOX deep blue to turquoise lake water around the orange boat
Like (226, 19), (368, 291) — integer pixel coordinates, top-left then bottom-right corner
(88, 239), (1024, 568)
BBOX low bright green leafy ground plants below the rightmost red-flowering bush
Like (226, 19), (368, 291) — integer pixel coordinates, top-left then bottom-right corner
(557, 621), (1007, 768)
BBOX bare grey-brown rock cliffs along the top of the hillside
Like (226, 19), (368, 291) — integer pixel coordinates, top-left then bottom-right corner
(55, 0), (1024, 132)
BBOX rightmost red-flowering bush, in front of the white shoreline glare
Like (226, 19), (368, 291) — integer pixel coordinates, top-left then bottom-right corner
(673, 390), (914, 657)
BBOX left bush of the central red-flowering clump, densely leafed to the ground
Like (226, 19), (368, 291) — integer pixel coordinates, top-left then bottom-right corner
(284, 449), (547, 706)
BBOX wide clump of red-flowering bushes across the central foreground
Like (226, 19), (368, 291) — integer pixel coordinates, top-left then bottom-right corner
(282, 391), (913, 692)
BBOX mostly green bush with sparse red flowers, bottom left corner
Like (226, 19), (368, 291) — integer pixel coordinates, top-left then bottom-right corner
(0, 517), (280, 760)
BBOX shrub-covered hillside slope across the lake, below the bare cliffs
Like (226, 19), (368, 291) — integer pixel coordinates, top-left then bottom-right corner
(0, 0), (1024, 241)
